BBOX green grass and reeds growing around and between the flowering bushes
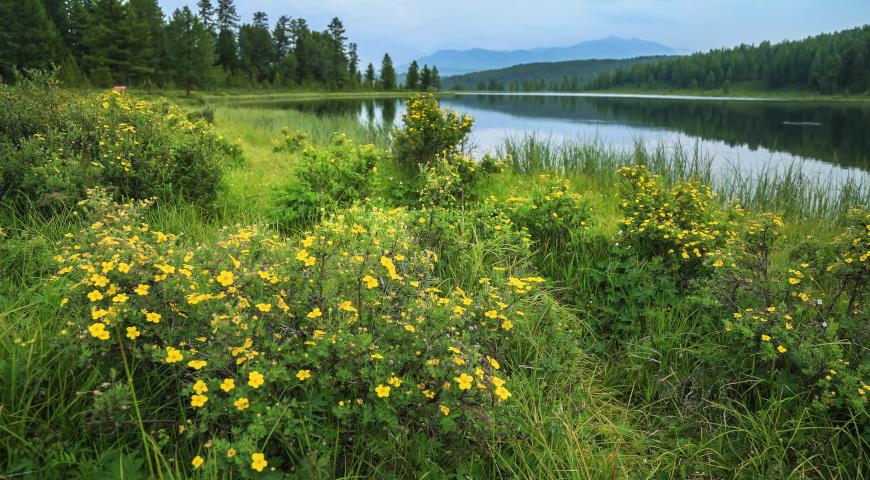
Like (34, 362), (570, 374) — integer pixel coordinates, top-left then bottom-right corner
(0, 85), (870, 479)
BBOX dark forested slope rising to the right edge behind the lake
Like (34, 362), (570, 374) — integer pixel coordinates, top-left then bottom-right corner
(586, 25), (870, 94)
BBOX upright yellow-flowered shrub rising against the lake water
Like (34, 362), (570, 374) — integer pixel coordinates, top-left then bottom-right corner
(393, 94), (474, 169)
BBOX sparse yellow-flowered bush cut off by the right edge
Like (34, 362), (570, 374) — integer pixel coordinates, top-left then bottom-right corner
(710, 211), (870, 415)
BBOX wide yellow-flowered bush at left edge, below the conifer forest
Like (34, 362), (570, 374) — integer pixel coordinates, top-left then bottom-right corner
(0, 74), (240, 210)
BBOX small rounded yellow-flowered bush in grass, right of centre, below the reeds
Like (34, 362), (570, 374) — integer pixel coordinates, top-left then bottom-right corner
(505, 175), (592, 251)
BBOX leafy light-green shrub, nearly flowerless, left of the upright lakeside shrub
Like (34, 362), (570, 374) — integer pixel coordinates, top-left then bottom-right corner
(273, 133), (388, 227)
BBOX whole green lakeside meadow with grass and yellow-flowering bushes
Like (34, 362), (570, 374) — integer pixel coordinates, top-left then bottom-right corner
(0, 73), (870, 479)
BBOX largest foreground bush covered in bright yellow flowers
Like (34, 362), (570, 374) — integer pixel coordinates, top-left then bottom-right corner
(54, 192), (543, 476)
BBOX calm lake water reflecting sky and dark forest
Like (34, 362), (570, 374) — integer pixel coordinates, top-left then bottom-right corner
(235, 94), (870, 182)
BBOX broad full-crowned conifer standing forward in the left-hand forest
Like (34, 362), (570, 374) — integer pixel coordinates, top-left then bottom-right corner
(166, 7), (214, 96)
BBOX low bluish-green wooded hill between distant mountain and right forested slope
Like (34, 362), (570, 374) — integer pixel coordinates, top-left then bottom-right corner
(442, 56), (666, 91)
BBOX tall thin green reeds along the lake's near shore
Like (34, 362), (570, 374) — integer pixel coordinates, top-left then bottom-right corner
(497, 134), (870, 220)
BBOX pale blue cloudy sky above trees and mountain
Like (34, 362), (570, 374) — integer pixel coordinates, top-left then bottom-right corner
(159, 0), (870, 65)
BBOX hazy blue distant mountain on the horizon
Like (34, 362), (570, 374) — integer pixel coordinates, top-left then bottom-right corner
(399, 37), (683, 76)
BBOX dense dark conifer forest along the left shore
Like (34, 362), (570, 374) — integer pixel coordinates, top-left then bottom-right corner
(0, 0), (397, 92)
